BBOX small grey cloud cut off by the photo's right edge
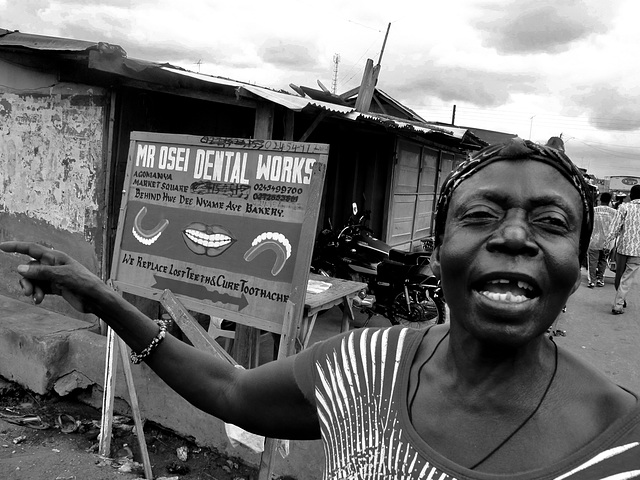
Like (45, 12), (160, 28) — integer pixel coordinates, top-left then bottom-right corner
(571, 85), (640, 132)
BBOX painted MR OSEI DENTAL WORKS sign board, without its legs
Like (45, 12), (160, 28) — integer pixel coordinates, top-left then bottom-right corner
(111, 132), (329, 332)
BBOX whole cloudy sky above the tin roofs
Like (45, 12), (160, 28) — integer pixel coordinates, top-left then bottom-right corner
(0, 0), (640, 178)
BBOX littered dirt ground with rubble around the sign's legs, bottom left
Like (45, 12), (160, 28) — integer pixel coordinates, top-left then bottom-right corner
(0, 381), (258, 480)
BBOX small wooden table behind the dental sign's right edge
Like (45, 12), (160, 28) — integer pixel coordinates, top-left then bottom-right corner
(297, 273), (367, 350)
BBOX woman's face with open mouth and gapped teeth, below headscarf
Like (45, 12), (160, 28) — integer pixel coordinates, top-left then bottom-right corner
(432, 160), (582, 346)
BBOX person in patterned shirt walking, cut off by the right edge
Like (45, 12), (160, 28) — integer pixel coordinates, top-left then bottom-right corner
(605, 185), (640, 315)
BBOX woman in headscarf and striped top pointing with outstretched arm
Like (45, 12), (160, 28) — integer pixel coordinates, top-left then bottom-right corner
(0, 139), (640, 479)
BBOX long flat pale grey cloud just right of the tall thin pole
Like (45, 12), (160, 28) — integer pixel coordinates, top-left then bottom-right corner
(385, 64), (541, 107)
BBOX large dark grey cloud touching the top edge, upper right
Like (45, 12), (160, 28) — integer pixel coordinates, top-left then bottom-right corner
(473, 0), (619, 54)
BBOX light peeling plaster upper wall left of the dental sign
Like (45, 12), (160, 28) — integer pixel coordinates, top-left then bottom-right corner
(0, 64), (104, 241)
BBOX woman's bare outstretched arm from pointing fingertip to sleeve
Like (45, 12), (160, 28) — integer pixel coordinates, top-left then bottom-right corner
(0, 242), (320, 439)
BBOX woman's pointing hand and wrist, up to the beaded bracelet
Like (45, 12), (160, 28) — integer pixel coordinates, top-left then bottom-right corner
(0, 242), (105, 313)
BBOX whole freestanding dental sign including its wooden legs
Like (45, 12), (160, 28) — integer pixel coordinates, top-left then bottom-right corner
(101, 132), (329, 480)
